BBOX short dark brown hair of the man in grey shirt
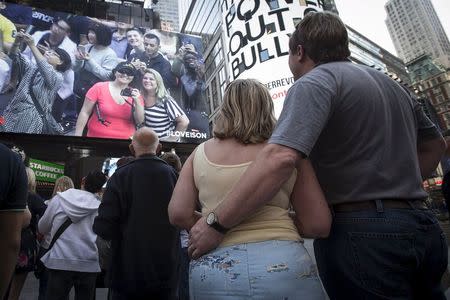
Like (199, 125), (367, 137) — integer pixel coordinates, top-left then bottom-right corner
(289, 12), (350, 64)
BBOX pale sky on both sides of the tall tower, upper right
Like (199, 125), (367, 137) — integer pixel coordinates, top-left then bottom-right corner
(335, 0), (450, 55)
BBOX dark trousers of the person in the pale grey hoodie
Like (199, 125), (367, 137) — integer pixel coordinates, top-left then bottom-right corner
(46, 269), (97, 300)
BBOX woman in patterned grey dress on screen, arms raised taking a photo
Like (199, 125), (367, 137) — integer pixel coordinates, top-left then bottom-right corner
(0, 31), (72, 134)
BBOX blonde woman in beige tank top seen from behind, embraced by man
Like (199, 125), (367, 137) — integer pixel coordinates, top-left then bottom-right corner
(168, 79), (331, 299)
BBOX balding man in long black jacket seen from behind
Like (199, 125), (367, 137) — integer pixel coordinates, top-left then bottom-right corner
(93, 127), (180, 299)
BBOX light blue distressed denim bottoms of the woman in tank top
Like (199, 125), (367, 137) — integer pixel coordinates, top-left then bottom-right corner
(189, 240), (325, 300)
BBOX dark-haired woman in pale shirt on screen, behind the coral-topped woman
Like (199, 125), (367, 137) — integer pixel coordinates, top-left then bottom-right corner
(73, 23), (118, 100)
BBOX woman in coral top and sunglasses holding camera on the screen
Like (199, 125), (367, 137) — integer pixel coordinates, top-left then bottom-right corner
(75, 62), (142, 139)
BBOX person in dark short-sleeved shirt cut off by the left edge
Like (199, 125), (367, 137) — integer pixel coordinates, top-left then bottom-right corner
(0, 144), (28, 299)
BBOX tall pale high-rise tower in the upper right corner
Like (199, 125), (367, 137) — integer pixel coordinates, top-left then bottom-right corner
(385, 0), (450, 68)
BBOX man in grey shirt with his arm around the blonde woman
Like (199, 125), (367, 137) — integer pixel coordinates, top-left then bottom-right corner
(188, 12), (448, 300)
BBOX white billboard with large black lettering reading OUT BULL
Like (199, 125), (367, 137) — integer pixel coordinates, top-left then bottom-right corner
(220, 0), (323, 117)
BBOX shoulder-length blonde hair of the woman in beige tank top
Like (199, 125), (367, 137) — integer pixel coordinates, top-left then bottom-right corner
(214, 79), (276, 144)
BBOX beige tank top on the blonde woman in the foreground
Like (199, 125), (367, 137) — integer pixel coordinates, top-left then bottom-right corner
(193, 143), (301, 247)
